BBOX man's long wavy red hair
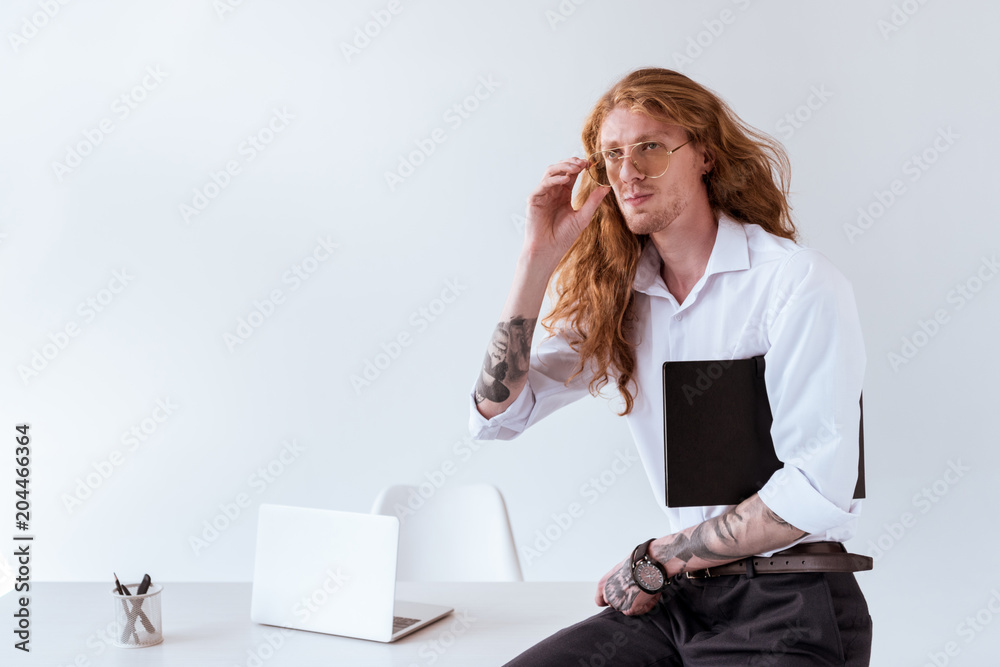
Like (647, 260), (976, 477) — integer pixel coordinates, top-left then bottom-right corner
(542, 68), (798, 416)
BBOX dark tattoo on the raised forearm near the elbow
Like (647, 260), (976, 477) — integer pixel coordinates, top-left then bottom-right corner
(476, 317), (538, 404)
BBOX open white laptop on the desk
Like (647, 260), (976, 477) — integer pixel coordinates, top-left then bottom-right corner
(250, 504), (454, 642)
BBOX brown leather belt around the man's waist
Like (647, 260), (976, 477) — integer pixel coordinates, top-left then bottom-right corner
(685, 542), (874, 579)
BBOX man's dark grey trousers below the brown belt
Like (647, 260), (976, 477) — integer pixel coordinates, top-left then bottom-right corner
(507, 572), (872, 667)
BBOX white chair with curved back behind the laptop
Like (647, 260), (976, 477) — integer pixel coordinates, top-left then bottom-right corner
(371, 484), (524, 581)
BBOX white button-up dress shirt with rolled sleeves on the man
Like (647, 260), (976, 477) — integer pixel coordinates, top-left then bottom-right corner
(469, 217), (866, 555)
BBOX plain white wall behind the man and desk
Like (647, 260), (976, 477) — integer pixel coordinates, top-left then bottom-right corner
(0, 0), (1000, 665)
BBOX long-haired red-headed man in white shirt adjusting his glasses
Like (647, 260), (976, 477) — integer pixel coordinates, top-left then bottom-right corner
(470, 69), (871, 667)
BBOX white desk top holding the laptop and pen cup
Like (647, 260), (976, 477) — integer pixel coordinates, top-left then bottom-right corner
(0, 582), (600, 667)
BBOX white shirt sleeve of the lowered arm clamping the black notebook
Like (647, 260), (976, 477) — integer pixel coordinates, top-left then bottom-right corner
(759, 249), (866, 533)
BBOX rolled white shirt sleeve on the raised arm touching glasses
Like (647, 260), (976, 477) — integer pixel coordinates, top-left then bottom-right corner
(469, 332), (591, 440)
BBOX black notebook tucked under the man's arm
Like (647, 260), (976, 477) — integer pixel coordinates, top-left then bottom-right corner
(663, 356), (865, 507)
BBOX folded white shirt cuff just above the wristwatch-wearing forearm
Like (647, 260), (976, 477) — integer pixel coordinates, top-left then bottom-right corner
(757, 465), (855, 534)
